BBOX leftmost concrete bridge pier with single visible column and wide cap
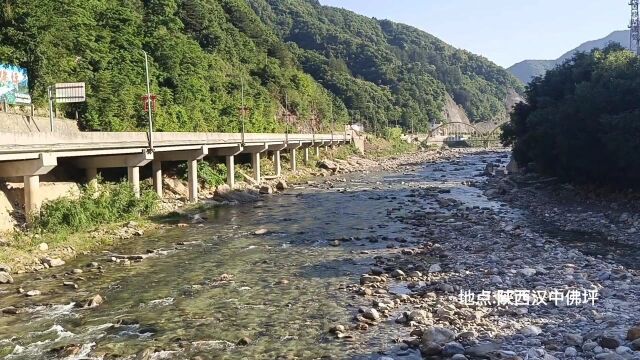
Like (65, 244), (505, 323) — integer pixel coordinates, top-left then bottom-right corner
(0, 153), (58, 222)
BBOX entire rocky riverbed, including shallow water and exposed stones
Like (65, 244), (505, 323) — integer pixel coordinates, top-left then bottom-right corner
(0, 152), (640, 360)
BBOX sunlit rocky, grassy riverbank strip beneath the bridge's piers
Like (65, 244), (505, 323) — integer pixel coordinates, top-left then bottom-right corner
(0, 142), (460, 274)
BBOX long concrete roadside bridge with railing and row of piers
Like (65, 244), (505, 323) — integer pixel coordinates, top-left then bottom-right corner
(0, 132), (352, 219)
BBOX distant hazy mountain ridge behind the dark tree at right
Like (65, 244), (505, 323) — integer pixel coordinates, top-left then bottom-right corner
(507, 30), (629, 84)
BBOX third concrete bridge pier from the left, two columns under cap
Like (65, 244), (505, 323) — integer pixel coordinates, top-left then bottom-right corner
(152, 146), (209, 202)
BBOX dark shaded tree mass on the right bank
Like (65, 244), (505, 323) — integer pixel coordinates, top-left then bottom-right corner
(502, 44), (640, 186)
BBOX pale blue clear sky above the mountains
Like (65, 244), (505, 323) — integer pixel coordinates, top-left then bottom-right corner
(320, 0), (631, 67)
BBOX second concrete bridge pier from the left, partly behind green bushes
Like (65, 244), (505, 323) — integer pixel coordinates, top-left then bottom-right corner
(75, 150), (153, 197)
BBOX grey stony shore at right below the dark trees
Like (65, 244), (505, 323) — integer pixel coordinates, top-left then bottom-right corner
(331, 154), (640, 360)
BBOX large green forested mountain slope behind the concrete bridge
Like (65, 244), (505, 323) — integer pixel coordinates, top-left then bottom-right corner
(0, 0), (522, 131)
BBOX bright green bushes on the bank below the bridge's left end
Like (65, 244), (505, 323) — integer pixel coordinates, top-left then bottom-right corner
(33, 182), (158, 233)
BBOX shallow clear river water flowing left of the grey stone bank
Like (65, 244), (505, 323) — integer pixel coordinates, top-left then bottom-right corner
(0, 153), (620, 359)
